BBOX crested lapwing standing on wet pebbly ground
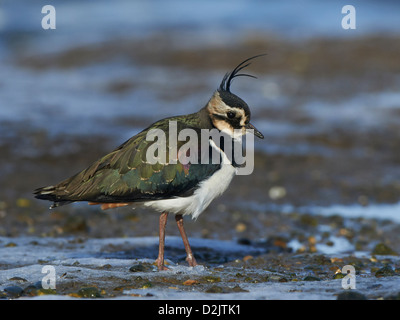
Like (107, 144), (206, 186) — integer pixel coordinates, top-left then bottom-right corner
(34, 54), (264, 271)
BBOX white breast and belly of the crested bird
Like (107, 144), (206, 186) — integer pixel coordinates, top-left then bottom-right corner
(143, 140), (236, 219)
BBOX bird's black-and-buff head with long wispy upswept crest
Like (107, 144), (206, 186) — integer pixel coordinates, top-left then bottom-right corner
(207, 55), (264, 139)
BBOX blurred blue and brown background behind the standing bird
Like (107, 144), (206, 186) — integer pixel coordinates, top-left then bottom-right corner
(0, 0), (400, 255)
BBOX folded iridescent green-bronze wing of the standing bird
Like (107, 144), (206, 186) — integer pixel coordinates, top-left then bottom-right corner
(60, 118), (220, 202)
